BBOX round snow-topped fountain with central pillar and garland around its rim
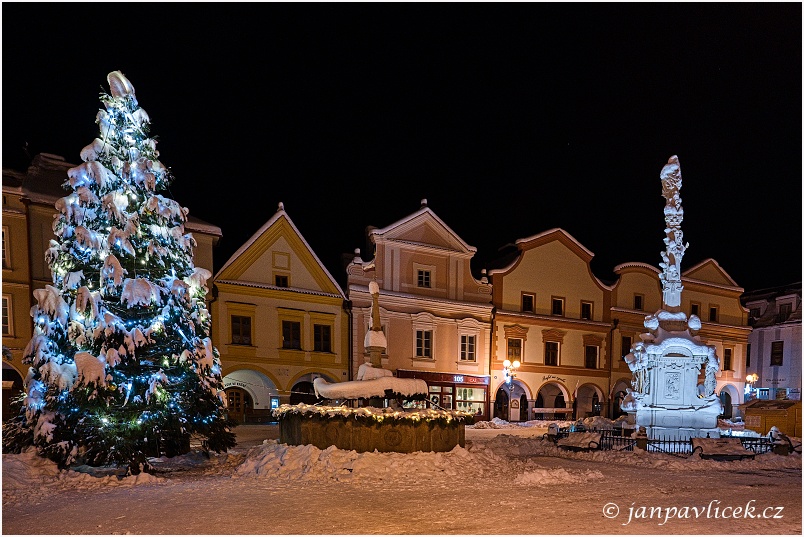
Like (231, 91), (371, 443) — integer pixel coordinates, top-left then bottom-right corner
(274, 281), (473, 453)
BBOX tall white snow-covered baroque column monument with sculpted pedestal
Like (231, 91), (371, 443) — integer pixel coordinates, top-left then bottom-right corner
(622, 155), (723, 438)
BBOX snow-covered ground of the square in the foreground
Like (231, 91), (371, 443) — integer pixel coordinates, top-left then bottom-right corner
(2, 420), (802, 535)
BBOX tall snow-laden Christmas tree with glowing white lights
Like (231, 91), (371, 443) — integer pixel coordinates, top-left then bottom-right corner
(3, 71), (235, 473)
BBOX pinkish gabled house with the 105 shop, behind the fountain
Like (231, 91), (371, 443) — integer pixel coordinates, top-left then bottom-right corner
(346, 200), (492, 420)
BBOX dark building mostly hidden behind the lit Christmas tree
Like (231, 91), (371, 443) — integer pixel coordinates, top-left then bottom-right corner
(2, 153), (221, 417)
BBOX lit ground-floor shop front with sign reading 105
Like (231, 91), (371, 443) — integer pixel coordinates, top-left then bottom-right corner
(396, 369), (490, 421)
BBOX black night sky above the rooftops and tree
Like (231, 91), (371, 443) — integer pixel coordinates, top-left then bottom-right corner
(2, 2), (802, 290)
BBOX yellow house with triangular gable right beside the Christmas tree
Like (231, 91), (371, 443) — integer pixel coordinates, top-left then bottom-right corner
(211, 203), (350, 423)
